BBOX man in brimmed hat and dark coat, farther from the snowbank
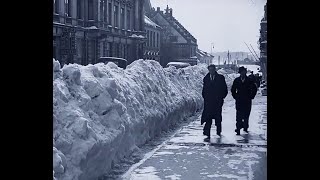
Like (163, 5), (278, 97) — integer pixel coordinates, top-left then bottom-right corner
(231, 66), (257, 135)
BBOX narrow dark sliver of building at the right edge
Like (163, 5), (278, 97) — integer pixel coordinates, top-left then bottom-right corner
(259, 3), (267, 81)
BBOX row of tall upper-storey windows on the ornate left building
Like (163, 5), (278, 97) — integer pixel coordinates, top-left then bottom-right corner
(53, 0), (131, 29)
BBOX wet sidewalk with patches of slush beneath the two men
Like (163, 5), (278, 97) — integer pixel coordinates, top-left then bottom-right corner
(123, 95), (267, 180)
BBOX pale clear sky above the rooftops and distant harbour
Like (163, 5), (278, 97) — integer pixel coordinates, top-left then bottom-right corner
(150, 0), (267, 53)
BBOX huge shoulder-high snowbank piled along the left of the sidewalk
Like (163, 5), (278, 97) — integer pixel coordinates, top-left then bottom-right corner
(53, 60), (208, 180)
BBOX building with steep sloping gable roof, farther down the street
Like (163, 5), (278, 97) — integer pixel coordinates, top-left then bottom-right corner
(146, 6), (198, 66)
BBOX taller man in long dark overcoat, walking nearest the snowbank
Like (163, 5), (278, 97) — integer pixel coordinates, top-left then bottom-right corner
(201, 64), (228, 140)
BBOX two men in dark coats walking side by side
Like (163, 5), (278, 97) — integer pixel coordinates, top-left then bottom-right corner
(201, 64), (257, 140)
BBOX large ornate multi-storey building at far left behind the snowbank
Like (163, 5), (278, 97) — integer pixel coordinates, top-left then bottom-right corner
(53, 0), (146, 65)
